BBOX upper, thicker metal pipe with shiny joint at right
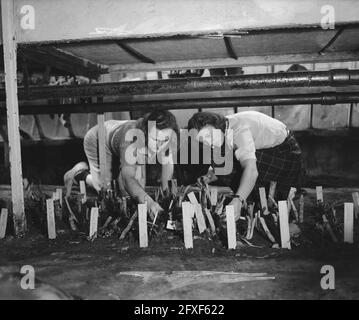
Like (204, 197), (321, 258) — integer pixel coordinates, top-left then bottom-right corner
(0, 69), (359, 101)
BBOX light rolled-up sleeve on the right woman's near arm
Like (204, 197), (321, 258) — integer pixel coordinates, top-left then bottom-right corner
(233, 128), (257, 163)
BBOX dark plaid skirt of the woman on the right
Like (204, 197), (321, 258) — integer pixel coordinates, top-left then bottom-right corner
(213, 133), (305, 199)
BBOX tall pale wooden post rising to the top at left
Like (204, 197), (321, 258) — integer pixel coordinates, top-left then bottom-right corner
(1, 0), (26, 237)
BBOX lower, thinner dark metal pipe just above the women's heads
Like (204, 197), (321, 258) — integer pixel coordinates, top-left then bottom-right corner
(0, 92), (359, 115)
